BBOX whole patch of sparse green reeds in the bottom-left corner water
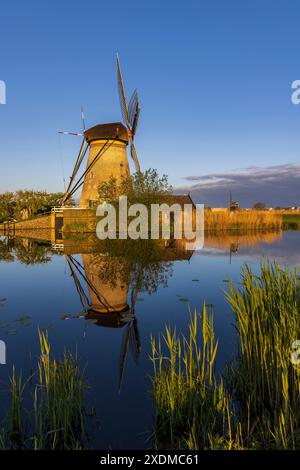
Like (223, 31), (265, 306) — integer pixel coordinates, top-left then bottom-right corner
(0, 333), (87, 450)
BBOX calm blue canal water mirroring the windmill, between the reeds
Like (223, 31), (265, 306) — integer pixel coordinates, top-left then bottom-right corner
(0, 232), (300, 449)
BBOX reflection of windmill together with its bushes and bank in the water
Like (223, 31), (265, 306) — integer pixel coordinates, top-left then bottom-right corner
(60, 240), (192, 392)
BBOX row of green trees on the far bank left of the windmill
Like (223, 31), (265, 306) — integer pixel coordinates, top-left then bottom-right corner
(0, 190), (73, 223)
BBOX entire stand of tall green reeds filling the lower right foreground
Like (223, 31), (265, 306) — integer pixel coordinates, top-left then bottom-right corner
(151, 264), (300, 449)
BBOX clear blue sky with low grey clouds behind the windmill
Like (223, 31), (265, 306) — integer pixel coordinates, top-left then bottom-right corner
(0, 0), (300, 206)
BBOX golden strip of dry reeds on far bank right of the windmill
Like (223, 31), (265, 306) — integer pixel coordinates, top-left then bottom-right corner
(205, 209), (282, 230)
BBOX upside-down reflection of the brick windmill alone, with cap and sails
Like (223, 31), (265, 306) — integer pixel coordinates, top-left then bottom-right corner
(65, 254), (141, 392)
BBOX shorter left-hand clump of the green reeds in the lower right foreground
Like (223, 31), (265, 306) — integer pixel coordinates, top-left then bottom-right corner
(151, 305), (242, 449)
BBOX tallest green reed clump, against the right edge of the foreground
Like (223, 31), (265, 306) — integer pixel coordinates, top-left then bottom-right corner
(226, 262), (300, 449)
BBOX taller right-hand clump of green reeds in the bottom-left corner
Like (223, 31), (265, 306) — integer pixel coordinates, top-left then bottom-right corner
(34, 332), (85, 449)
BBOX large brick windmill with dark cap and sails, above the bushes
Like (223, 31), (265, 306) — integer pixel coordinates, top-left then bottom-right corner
(62, 55), (140, 208)
